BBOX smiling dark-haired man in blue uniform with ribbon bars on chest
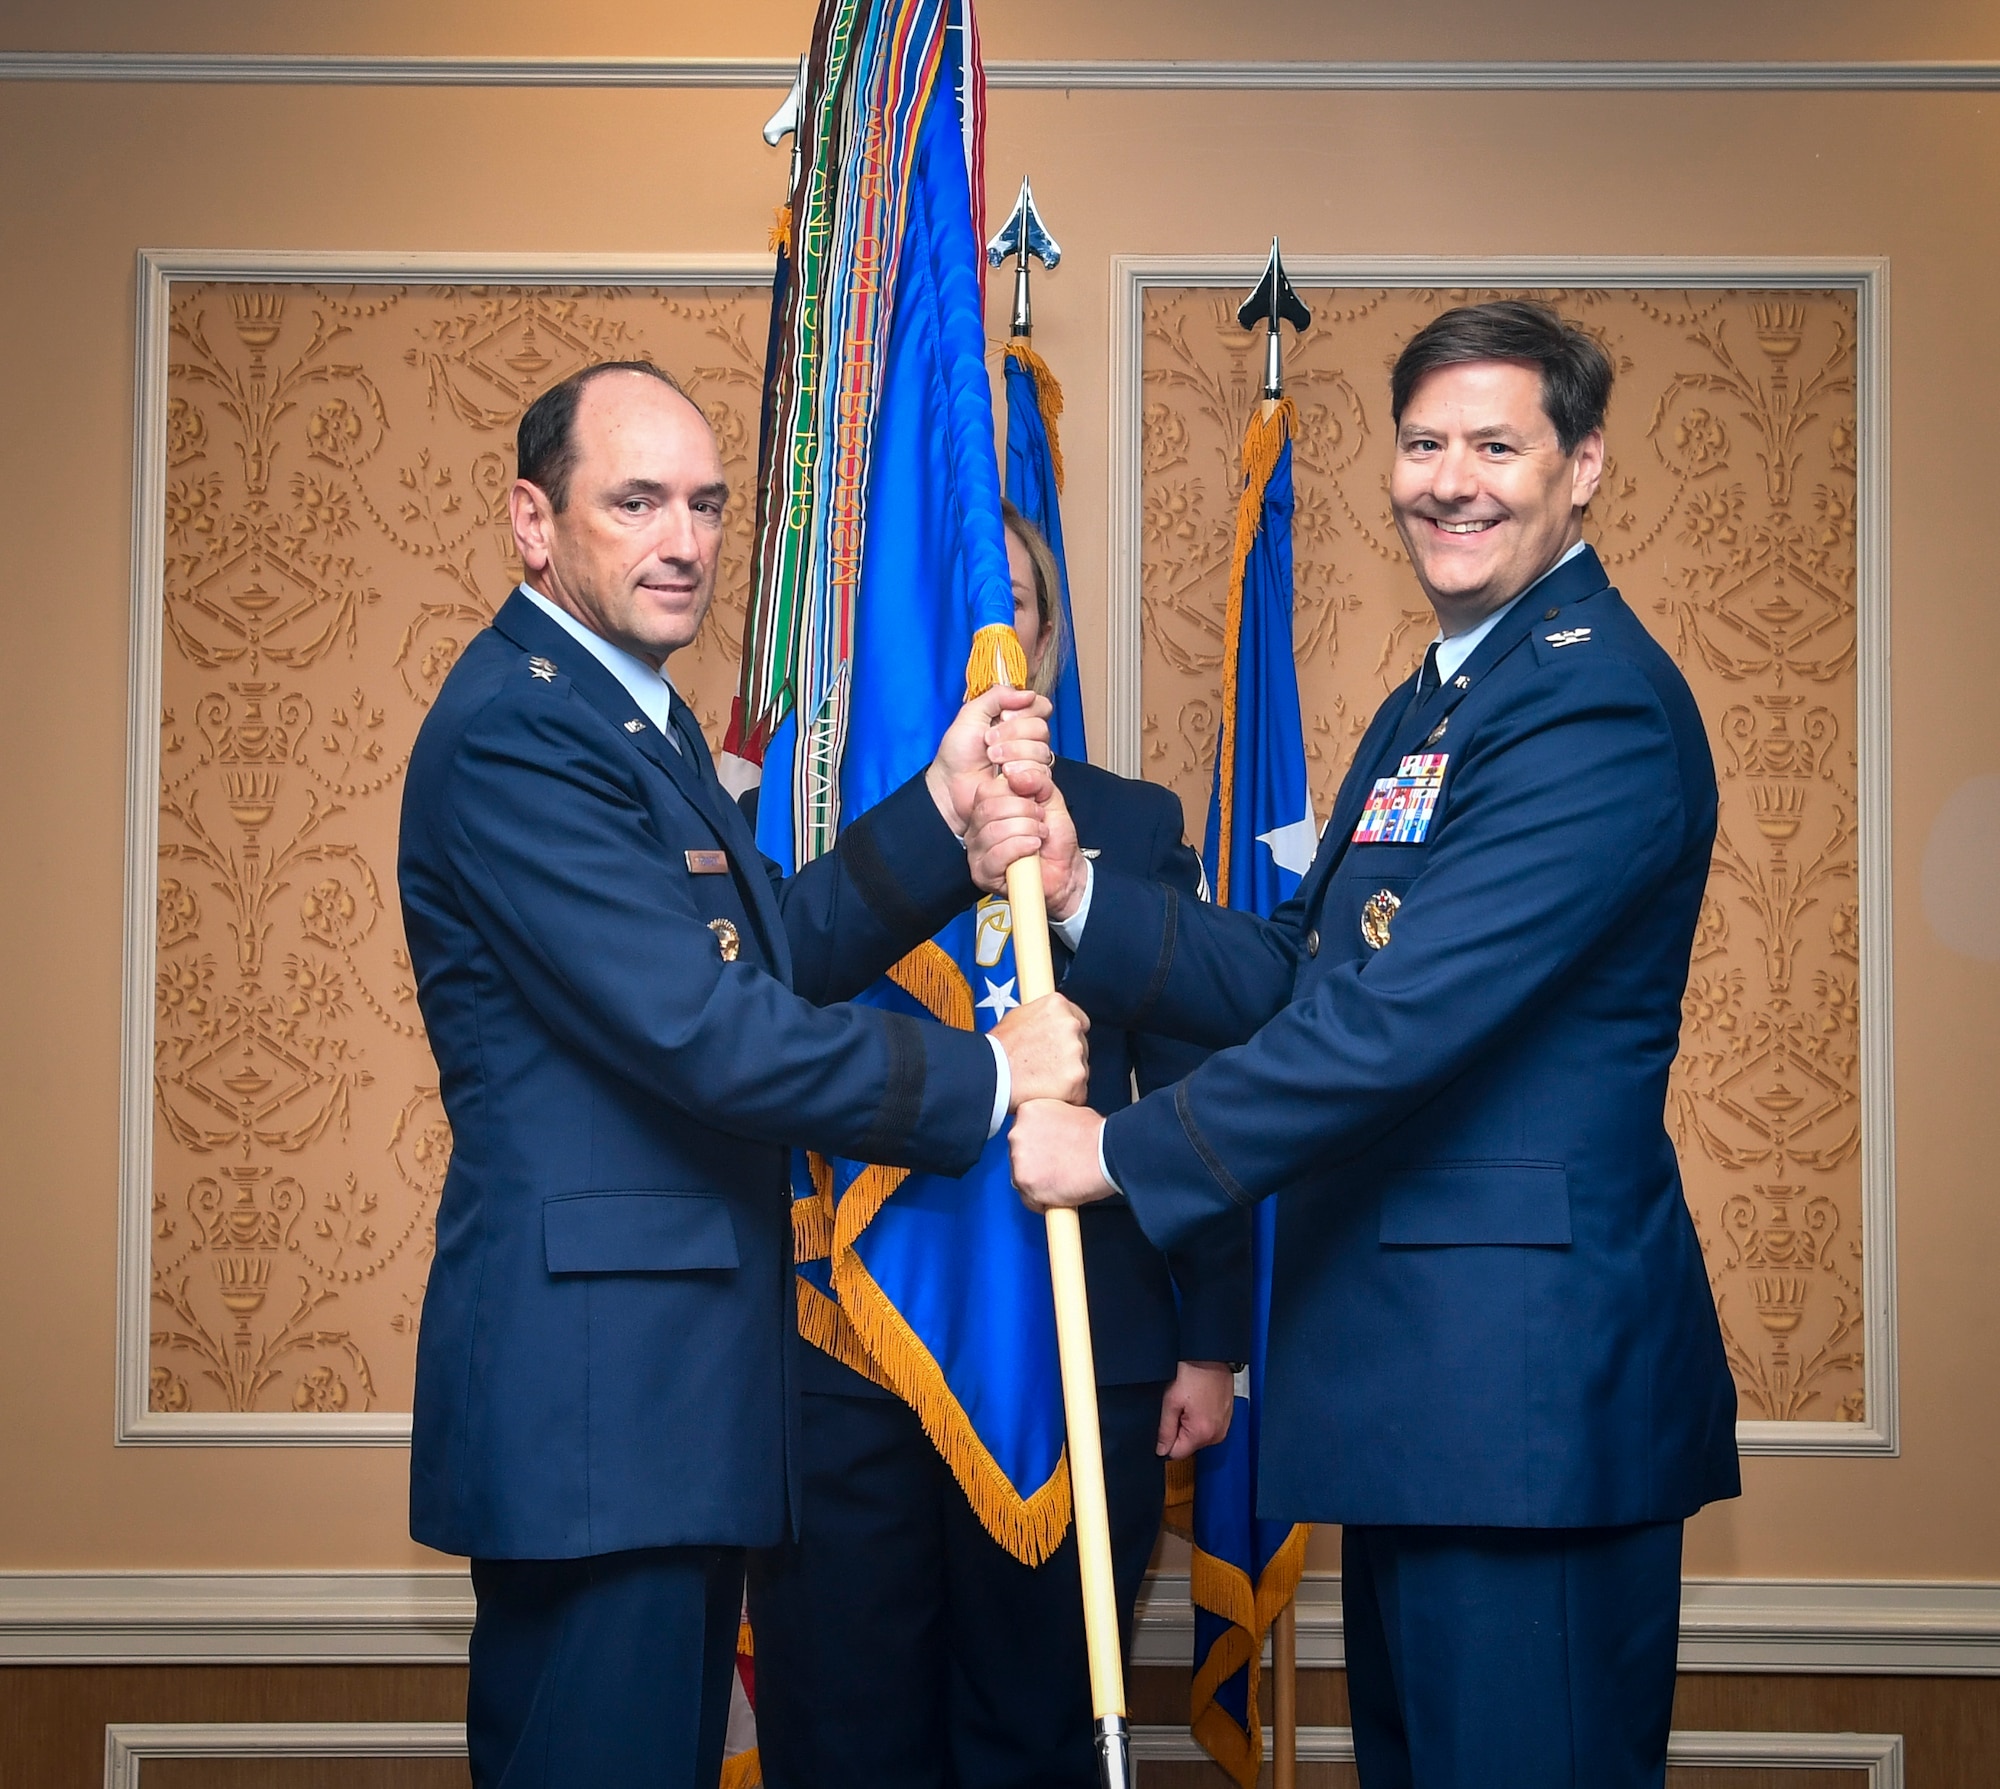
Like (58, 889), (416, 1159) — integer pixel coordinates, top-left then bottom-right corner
(1012, 302), (1738, 1789)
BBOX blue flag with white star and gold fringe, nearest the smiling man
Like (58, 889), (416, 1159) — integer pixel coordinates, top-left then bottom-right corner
(1188, 398), (1318, 1789)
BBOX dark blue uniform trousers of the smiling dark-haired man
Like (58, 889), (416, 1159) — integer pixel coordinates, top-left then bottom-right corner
(1340, 1523), (1682, 1789)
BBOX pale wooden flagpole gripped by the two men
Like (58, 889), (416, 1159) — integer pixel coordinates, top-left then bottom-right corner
(1006, 824), (1132, 1789)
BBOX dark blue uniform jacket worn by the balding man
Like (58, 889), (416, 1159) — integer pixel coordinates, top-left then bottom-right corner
(400, 594), (994, 1559)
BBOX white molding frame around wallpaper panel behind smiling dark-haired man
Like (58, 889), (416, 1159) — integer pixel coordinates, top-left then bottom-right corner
(1104, 254), (1900, 1455)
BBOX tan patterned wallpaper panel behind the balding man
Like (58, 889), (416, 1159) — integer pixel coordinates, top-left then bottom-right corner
(126, 260), (770, 1439)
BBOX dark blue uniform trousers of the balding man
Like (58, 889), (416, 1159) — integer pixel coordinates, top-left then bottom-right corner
(466, 1547), (744, 1789)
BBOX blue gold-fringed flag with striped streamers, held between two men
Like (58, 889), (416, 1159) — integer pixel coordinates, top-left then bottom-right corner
(726, 0), (1070, 1565)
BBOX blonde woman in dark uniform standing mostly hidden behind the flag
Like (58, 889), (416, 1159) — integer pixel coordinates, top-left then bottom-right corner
(750, 504), (1250, 1789)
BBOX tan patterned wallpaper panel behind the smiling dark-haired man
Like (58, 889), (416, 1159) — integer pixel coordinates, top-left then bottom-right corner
(1134, 280), (1888, 1445)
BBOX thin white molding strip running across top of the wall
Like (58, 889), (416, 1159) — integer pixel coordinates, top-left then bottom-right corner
(11, 50), (2000, 92)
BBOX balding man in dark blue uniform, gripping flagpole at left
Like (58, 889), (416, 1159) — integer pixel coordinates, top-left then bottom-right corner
(400, 364), (1086, 1789)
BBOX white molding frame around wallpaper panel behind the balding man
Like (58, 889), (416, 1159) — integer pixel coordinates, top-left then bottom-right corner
(116, 248), (772, 1447)
